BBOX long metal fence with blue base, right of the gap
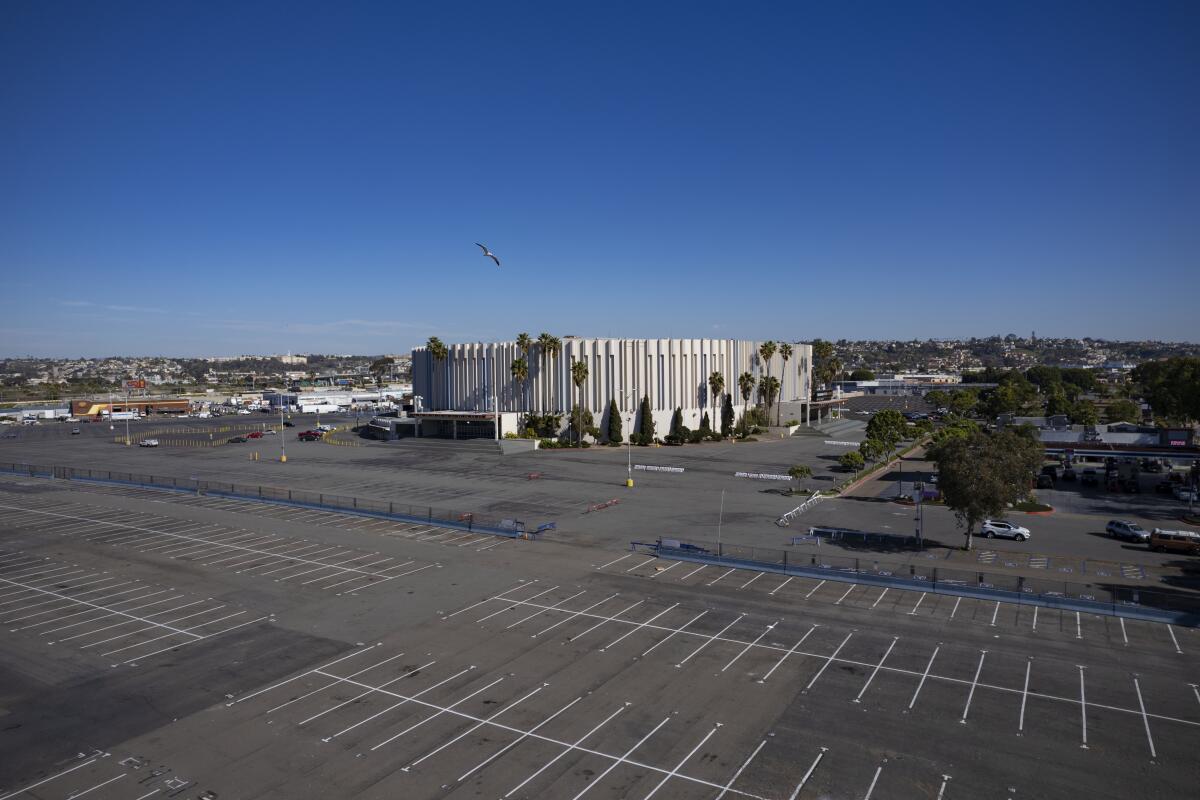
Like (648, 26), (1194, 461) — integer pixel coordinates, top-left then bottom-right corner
(641, 539), (1200, 627)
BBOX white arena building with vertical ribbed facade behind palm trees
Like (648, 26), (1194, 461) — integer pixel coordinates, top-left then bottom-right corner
(413, 336), (812, 438)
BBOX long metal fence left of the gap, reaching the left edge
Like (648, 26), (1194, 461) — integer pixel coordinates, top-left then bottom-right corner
(0, 463), (544, 539)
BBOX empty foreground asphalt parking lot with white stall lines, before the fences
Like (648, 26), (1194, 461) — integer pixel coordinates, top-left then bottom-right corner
(0, 462), (1200, 800)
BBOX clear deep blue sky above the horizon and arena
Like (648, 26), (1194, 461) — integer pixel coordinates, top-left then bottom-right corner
(0, 0), (1200, 355)
